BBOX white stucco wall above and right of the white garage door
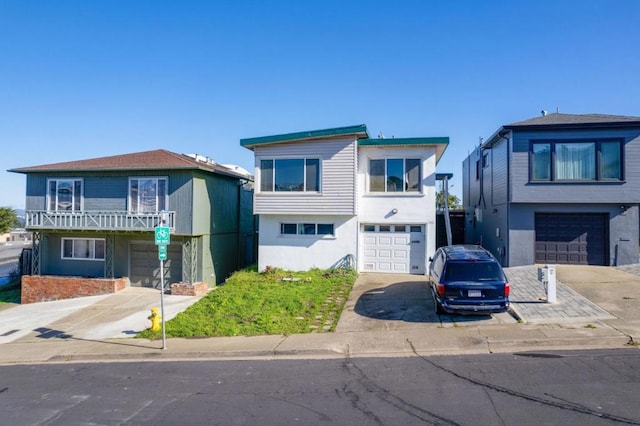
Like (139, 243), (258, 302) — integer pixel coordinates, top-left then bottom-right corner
(357, 146), (436, 262)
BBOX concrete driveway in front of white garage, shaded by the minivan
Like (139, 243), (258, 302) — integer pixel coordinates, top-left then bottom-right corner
(336, 273), (517, 332)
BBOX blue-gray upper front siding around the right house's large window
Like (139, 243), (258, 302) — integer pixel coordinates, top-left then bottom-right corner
(510, 129), (640, 203)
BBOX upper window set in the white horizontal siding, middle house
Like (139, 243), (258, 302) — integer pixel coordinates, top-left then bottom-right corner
(260, 158), (320, 192)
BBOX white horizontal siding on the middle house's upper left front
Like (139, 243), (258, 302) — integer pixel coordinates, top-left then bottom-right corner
(254, 138), (356, 215)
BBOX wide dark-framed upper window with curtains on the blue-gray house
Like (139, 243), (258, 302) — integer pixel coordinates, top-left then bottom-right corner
(530, 141), (622, 181)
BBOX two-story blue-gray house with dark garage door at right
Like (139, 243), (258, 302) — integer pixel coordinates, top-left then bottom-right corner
(463, 111), (640, 266)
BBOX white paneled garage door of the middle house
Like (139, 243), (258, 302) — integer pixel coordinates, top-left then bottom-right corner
(362, 225), (425, 274)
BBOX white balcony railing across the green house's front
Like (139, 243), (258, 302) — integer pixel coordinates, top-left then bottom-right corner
(25, 210), (176, 231)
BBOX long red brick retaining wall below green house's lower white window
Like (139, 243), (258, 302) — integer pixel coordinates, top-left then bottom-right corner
(21, 275), (129, 304)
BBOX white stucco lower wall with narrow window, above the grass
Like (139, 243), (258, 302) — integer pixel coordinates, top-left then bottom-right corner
(258, 215), (358, 271)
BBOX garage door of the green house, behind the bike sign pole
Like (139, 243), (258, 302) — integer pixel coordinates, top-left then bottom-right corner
(129, 242), (182, 288)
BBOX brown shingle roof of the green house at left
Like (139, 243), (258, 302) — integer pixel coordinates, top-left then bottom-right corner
(9, 149), (252, 179)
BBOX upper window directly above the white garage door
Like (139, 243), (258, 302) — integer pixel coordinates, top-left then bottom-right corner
(369, 158), (422, 192)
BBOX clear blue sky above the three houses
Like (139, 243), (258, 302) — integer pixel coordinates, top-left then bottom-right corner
(0, 0), (640, 208)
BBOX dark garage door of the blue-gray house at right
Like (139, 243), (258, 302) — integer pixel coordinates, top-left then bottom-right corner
(535, 213), (609, 265)
